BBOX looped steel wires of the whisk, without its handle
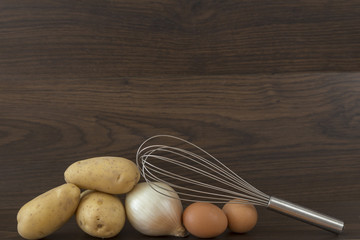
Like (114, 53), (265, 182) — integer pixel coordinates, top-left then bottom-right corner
(136, 135), (269, 206)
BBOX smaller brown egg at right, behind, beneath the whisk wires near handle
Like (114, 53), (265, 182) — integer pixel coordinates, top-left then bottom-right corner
(223, 199), (257, 233)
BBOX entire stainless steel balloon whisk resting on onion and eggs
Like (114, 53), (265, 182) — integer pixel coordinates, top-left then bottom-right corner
(136, 135), (344, 234)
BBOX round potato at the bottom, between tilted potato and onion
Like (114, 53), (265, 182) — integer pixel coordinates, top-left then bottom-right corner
(76, 191), (125, 238)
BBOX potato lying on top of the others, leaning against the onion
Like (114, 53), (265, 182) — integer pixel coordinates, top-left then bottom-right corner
(64, 157), (140, 194)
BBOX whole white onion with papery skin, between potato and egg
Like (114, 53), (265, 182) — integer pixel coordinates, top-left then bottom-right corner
(125, 182), (186, 237)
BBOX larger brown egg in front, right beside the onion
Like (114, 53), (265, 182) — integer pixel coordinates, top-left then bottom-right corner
(183, 202), (228, 238)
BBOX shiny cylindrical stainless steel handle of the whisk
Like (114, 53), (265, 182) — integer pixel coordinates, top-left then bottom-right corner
(267, 197), (344, 234)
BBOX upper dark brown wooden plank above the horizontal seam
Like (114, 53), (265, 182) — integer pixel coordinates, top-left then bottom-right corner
(0, 0), (360, 79)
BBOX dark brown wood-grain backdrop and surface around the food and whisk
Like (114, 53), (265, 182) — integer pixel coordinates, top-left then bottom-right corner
(0, 0), (360, 240)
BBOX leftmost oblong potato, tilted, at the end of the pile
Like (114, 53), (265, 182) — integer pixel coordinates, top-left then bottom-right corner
(17, 183), (80, 239)
